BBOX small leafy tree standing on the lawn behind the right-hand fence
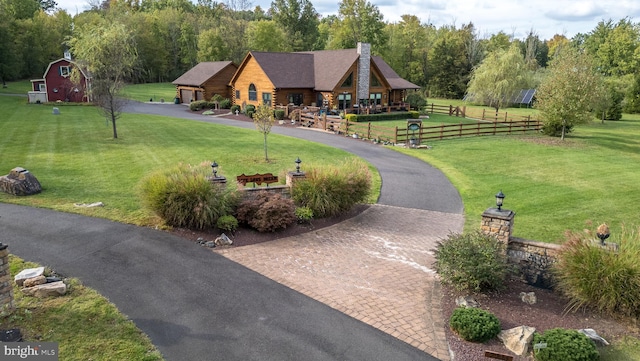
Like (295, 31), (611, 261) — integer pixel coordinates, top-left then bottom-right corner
(536, 46), (602, 140)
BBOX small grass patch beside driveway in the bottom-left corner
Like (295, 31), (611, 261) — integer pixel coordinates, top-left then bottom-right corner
(0, 256), (163, 361)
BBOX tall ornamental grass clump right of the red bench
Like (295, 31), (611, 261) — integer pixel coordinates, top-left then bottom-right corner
(291, 160), (371, 218)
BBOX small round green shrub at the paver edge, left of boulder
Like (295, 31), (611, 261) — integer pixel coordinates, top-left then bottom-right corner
(449, 307), (501, 342)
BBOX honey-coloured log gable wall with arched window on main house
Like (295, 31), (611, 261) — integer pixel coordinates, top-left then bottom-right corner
(231, 57), (281, 107)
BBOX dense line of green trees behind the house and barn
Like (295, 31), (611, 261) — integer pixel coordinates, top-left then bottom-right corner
(0, 0), (640, 112)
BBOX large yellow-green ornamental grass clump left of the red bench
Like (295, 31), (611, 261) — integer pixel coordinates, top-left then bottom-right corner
(141, 163), (238, 229)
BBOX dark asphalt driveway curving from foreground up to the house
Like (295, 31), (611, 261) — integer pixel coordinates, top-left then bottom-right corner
(0, 104), (462, 361)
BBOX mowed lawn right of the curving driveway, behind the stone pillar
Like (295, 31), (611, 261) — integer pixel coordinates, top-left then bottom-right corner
(399, 115), (640, 242)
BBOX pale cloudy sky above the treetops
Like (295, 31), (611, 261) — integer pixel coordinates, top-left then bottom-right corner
(56, 0), (640, 39)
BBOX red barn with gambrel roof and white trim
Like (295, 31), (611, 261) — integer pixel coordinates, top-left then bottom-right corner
(29, 54), (91, 103)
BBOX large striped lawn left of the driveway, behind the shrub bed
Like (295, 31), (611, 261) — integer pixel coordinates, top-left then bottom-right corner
(0, 97), (381, 225)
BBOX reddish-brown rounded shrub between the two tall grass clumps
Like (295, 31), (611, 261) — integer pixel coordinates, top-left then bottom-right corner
(238, 191), (296, 232)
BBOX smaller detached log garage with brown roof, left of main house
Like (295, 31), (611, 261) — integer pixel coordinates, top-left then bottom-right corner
(173, 61), (238, 104)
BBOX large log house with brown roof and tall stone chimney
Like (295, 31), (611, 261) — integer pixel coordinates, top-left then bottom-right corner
(230, 43), (420, 109)
